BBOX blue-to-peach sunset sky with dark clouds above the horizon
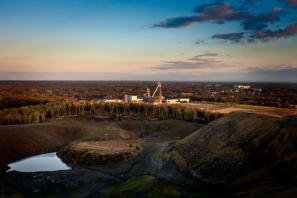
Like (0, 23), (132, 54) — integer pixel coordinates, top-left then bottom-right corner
(0, 0), (297, 82)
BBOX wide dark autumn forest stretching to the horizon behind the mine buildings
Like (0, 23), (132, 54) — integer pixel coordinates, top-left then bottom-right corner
(0, 81), (297, 108)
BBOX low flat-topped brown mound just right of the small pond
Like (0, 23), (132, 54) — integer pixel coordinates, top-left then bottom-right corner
(58, 139), (142, 165)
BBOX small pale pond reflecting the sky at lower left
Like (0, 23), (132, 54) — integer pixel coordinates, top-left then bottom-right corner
(7, 153), (71, 172)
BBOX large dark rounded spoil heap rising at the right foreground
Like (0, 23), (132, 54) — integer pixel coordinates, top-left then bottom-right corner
(171, 112), (297, 196)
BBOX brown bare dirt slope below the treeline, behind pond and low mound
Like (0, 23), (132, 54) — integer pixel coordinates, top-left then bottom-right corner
(0, 118), (203, 171)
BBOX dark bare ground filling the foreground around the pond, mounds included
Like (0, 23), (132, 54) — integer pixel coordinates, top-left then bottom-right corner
(0, 112), (297, 197)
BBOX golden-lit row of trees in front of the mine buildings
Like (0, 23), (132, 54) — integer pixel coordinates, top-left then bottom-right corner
(0, 102), (222, 125)
